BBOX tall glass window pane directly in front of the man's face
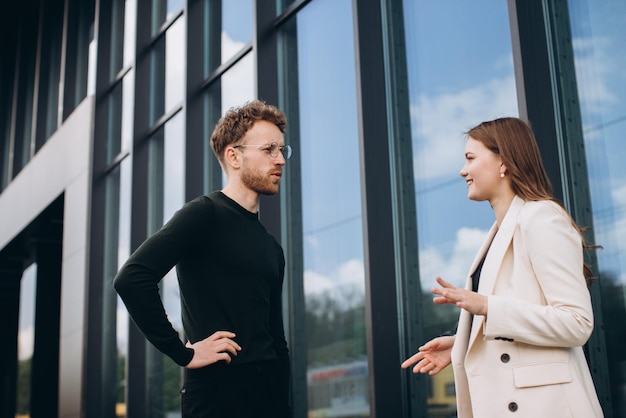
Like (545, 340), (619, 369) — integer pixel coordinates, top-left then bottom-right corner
(294, 0), (370, 416)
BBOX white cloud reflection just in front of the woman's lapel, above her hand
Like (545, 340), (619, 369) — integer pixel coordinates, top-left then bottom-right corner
(419, 228), (487, 289)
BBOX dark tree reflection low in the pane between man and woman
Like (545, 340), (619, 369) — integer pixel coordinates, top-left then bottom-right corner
(306, 288), (367, 365)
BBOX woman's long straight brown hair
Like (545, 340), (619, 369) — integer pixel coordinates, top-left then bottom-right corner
(465, 117), (599, 286)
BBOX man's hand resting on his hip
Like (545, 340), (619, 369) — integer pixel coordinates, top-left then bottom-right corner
(186, 331), (241, 369)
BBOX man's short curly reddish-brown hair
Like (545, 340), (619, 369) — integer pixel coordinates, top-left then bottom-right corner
(211, 100), (287, 166)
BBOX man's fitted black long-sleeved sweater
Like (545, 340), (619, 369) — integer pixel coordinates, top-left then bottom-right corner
(114, 192), (289, 379)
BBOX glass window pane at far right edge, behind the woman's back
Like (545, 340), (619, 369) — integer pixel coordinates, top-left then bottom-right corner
(568, 0), (626, 417)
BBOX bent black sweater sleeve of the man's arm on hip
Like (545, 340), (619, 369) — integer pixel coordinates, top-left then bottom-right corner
(113, 199), (210, 366)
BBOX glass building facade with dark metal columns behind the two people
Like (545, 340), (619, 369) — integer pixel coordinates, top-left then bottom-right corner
(0, 0), (626, 418)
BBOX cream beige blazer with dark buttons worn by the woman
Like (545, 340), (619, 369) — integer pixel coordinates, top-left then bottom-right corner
(452, 197), (603, 418)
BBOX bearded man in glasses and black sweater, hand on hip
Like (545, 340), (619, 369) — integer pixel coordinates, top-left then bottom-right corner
(114, 100), (291, 418)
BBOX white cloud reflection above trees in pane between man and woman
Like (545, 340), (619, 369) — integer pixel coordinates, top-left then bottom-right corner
(304, 259), (365, 300)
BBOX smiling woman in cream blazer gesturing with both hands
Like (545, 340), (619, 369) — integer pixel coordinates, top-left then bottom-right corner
(402, 118), (603, 418)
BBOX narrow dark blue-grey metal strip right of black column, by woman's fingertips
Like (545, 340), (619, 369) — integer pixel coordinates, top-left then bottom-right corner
(382, 0), (429, 417)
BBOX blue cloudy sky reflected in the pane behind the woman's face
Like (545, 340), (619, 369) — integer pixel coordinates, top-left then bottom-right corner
(404, 0), (518, 289)
